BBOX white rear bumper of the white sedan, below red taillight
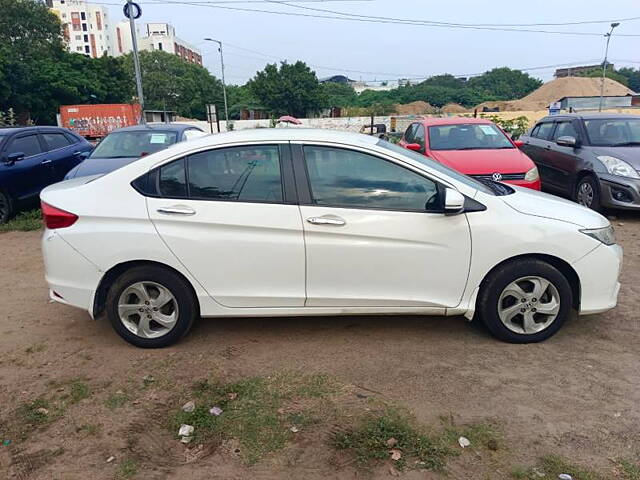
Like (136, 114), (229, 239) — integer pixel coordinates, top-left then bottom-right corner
(42, 230), (102, 313)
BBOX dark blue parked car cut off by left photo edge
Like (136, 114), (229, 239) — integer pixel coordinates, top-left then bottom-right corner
(0, 127), (93, 224)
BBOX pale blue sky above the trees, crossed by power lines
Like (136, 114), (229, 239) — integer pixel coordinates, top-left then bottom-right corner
(102, 0), (640, 84)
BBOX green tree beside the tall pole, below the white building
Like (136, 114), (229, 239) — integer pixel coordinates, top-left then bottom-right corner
(125, 51), (224, 120)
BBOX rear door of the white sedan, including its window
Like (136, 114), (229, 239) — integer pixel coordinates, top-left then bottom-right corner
(147, 143), (305, 307)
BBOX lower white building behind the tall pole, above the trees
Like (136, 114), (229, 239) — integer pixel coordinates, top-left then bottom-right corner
(113, 21), (202, 66)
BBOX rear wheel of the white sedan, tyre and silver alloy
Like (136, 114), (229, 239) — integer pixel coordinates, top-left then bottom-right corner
(106, 266), (200, 348)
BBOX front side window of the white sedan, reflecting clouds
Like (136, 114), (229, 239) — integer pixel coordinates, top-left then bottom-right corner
(304, 146), (440, 212)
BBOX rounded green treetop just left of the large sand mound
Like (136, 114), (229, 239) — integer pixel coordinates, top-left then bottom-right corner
(467, 67), (542, 100)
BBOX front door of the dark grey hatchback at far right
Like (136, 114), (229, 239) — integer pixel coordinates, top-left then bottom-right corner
(546, 119), (580, 196)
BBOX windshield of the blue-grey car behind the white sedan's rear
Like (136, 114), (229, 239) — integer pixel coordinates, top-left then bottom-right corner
(90, 131), (177, 158)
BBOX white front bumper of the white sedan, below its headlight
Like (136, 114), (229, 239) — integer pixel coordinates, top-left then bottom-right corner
(573, 244), (622, 315)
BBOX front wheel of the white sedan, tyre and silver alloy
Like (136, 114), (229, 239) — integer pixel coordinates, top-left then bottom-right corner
(476, 259), (573, 343)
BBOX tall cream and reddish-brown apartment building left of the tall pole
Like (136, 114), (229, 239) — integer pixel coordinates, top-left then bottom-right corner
(46, 0), (114, 58)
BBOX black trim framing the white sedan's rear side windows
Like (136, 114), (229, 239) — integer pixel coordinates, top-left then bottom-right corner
(139, 142), (298, 205)
